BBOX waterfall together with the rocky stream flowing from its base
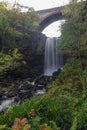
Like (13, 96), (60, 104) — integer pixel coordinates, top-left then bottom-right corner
(0, 38), (63, 112)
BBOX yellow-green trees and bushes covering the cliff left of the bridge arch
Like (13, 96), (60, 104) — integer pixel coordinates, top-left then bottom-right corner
(0, 2), (40, 81)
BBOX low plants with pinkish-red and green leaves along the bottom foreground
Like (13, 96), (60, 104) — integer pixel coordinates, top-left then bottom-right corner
(1, 109), (60, 130)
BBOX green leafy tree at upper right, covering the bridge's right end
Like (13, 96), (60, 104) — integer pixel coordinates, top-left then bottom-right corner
(60, 0), (87, 52)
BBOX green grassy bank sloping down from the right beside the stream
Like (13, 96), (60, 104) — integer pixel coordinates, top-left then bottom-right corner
(0, 57), (87, 130)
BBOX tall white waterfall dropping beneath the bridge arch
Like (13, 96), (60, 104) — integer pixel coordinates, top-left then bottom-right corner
(44, 38), (63, 76)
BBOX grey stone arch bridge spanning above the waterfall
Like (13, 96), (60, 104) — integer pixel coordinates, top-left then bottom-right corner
(37, 6), (64, 31)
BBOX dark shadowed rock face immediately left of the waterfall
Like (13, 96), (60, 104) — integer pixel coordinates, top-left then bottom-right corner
(19, 32), (46, 78)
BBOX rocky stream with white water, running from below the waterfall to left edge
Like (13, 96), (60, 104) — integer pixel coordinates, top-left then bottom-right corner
(0, 76), (46, 113)
